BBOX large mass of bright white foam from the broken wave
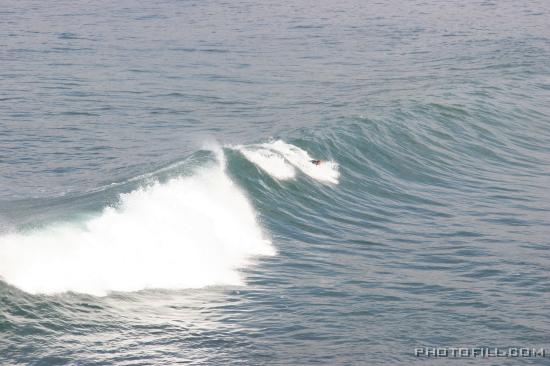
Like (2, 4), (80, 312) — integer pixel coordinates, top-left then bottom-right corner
(0, 157), (275, 295)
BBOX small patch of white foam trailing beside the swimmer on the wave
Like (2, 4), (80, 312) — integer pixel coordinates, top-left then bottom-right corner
(232, 140), (340, 184)
